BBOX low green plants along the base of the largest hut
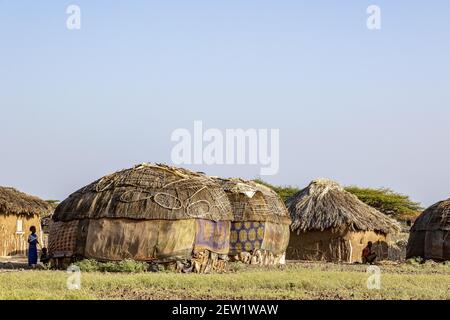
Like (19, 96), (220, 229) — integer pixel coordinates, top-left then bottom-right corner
(74, 259), (149, 273)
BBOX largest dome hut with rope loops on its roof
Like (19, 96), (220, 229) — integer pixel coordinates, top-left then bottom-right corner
(49, 164), (233, 272)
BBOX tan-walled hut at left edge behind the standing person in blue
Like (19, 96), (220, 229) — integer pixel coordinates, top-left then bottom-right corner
(0, 187), (52, 257)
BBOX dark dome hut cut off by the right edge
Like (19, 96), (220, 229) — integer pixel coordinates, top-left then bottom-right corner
(406, 199), (450, 261)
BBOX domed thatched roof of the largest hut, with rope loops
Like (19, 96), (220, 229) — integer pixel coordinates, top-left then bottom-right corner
(53, 163), (233, 221)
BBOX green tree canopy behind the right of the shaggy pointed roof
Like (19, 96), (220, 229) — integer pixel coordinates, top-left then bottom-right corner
(345, 186), (423, 218)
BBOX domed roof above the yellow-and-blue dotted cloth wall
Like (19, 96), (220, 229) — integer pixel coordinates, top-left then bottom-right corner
(216, 178), (291, 224)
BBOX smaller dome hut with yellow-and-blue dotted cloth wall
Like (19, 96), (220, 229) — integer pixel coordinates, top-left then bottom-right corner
(217, 179), (291, 265)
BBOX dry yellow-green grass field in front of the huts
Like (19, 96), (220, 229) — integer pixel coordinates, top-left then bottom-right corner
(0, 262), (450, 300)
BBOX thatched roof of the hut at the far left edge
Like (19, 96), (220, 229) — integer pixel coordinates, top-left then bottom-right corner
(0, 187), (52, 215)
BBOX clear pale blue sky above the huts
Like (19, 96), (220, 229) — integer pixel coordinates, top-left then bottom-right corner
(0, 0), (450, 205)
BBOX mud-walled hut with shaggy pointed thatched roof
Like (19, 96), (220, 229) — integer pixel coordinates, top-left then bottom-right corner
(286, 179), (400, 262)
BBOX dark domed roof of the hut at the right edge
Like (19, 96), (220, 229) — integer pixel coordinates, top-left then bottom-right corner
(411, 199), (450, 232)
